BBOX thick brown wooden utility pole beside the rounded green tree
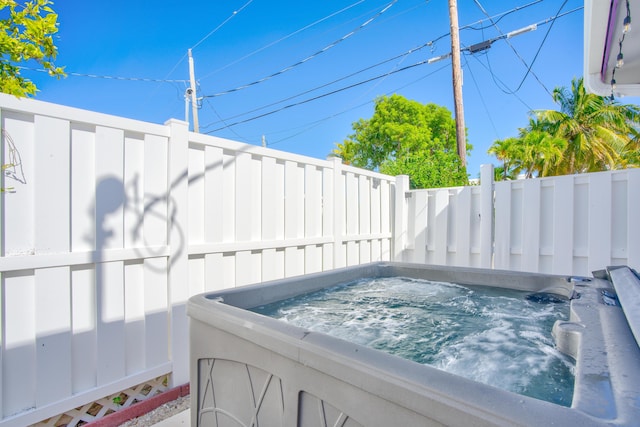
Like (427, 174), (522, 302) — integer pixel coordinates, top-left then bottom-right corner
(449, 0), (467, 166)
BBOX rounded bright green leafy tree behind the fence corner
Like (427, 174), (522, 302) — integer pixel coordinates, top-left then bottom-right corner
(332, 94), (470, 188)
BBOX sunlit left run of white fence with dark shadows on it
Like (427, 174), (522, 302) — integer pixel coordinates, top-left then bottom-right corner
(0, 95), (394, 426)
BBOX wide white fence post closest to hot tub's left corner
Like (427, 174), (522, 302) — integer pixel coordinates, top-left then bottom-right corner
(165, 119), (190, 387)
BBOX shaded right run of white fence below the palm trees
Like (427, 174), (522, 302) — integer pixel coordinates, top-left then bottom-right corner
(396, 165), (640, 276)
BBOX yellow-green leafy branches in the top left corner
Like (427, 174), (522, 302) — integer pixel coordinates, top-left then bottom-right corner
(0, 0), (64, 96)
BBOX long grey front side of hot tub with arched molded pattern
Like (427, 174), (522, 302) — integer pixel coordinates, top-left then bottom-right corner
(189, 298), (602, 427)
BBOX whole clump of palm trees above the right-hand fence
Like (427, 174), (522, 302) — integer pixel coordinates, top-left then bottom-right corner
(489, 79), (640, 179)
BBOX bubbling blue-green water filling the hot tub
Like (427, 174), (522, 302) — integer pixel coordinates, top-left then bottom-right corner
(254, 277), (574, 406)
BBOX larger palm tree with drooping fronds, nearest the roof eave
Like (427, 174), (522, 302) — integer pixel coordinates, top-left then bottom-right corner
(533, 78), (640, 175)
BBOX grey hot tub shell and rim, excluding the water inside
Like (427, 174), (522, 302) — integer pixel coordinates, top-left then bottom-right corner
(187, 263), (640, 426)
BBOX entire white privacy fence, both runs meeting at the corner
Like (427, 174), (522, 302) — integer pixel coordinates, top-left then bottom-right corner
(0, 94), (640, 426)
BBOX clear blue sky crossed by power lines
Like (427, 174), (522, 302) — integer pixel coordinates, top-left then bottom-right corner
(23, 0), (633, 177)
